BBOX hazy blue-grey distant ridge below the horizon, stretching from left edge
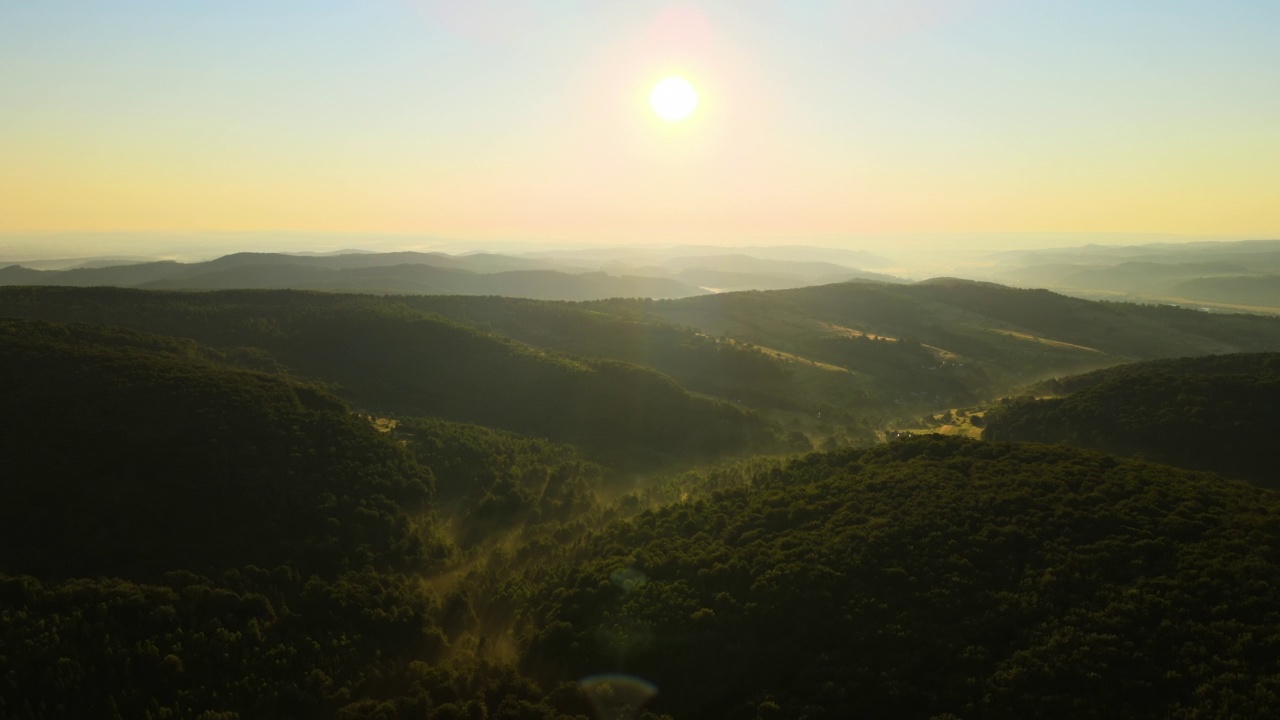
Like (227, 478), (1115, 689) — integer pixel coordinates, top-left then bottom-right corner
(0, 245), (901, 300)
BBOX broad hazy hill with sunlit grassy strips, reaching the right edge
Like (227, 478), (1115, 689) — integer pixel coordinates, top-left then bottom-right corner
(391, 279), (1280, 442)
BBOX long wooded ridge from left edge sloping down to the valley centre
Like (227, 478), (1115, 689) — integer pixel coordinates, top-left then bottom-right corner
(0, 288), (808, 468)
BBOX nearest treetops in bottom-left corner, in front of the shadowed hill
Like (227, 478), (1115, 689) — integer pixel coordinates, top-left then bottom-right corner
(0, 566), (611, 720)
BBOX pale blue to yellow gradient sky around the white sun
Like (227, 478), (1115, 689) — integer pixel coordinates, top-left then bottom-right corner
(0, 0), (1280, 254)
